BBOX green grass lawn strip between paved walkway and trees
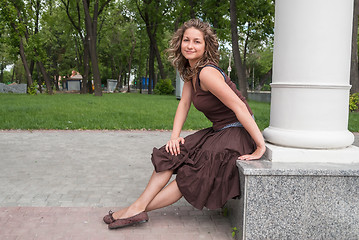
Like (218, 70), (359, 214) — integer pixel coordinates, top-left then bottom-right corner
(0, 93), (359, 132)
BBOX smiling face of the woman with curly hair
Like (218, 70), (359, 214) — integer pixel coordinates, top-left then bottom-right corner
(181, 27), (205, 66)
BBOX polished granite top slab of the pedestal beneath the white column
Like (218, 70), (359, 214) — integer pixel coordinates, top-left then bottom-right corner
(237, 160), (359, 177)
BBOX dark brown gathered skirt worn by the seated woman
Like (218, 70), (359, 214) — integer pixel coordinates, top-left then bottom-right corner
(151, 127), (256, 209)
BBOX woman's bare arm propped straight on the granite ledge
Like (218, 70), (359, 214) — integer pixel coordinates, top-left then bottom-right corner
(200, 67), (266, 160)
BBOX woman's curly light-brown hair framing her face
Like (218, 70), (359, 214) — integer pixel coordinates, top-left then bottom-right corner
(167, 19), (219, 82)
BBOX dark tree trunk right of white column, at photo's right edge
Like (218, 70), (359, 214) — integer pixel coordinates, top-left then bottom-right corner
(350, 0), (359, 93)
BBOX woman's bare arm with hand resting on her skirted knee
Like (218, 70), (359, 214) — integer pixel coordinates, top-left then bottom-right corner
(166, 82), (192, 155)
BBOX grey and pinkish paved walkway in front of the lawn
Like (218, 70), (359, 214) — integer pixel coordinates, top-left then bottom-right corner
(0, 131), (359, 240)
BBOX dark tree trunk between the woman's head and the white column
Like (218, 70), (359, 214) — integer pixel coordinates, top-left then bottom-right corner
(230, 0), (248, 98)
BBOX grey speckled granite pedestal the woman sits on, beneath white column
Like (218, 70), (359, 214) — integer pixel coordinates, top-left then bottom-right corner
(227, 160), (359, 240)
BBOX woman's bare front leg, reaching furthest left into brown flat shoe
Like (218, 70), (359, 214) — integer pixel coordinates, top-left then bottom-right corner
(112, 170), (173, 219)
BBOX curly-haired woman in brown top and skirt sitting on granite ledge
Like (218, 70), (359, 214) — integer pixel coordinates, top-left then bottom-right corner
(104, 19), (265, 229)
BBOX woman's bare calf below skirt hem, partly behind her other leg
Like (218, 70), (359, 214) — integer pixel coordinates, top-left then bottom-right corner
(146, 180), (182, 212)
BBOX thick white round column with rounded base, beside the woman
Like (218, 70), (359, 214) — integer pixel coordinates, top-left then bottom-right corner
(263, 0), (359, 161)
